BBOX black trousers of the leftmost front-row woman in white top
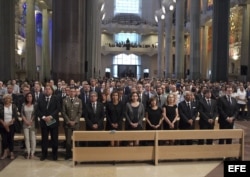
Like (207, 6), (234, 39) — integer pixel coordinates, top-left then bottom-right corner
(1, 125), (15, 152)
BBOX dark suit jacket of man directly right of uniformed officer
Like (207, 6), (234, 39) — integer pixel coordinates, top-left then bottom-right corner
(84, 102), (105, 130)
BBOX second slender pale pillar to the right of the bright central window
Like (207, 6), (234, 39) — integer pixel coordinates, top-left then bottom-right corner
(165, 10), (173, 78)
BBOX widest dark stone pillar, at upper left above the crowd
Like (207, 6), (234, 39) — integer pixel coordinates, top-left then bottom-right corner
(51, 0), (86, 82)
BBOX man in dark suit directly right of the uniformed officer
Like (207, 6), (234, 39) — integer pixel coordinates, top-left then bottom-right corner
(85, 92), (105, 130)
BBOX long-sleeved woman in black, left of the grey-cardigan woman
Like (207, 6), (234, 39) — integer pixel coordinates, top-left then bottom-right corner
(106, 91), (124, 146)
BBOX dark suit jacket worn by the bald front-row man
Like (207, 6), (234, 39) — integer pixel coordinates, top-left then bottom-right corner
(178, 100), (198, 129)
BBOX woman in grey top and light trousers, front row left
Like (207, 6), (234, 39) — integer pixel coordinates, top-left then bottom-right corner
(21, 93), (36, 159)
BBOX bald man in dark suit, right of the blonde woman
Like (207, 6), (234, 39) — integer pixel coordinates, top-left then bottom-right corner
(178, 91), (198, 145)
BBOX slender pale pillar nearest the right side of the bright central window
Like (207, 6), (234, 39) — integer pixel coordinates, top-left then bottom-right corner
(157, 16), (164, 78)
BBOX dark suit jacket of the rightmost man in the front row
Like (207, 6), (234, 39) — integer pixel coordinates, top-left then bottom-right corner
(218, 96), (238, 128)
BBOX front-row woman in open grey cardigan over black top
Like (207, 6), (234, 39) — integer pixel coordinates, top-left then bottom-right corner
(125, 92), (145, 146)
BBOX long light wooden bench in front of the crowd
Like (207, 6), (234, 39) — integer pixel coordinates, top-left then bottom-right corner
(72, 129), (244, 165)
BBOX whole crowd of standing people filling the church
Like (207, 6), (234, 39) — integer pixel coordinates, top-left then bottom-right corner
(0, 78), (250, 161)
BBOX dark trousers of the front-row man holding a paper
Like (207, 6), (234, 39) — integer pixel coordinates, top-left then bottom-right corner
(41, 126), (58, 157)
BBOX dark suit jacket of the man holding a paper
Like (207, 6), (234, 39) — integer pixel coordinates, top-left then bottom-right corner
(37, 95), (60, 128)
